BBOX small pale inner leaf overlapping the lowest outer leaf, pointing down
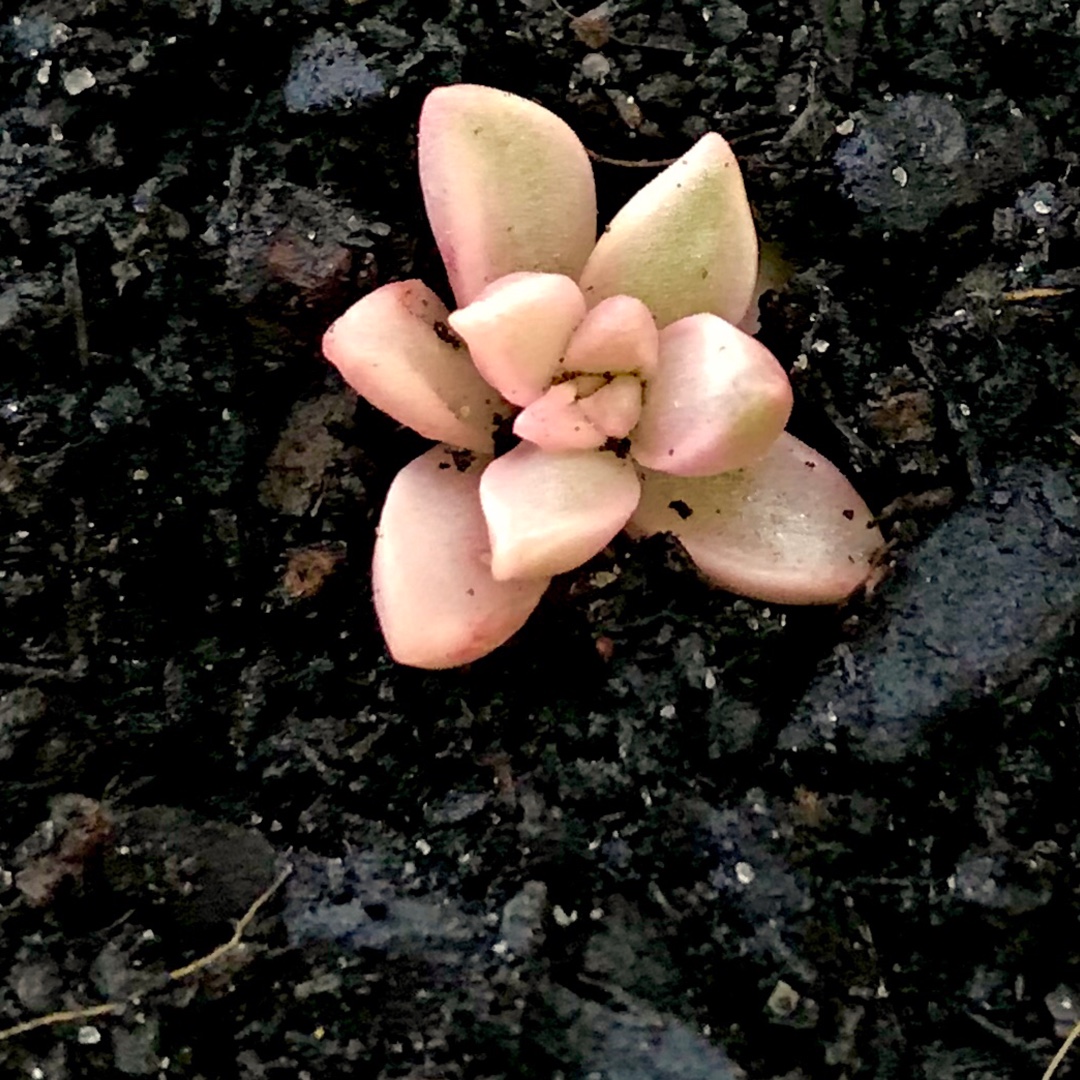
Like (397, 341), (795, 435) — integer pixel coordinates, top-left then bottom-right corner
(480, 443), (640, 581)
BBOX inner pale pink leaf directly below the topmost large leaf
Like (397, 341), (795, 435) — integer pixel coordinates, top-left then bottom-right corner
(449, 273), (585, 405)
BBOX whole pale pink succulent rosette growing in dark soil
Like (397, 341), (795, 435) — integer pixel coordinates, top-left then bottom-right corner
(323, 85), (881, 669)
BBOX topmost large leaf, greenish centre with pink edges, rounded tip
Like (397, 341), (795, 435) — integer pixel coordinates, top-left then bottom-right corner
(419, 84), (596, 308)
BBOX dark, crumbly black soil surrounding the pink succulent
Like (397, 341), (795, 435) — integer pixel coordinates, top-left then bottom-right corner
(0, 0), (1080, 1080)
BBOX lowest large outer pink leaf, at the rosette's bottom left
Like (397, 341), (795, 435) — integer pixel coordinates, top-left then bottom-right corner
(373, 446), (548, 669)
